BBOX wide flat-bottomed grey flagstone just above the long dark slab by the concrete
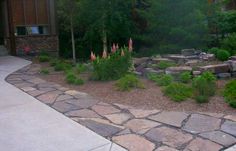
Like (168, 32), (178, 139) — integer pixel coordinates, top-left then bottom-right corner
(65, 109), (101, 118)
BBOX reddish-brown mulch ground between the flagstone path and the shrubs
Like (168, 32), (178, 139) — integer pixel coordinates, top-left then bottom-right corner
(37, 64), (236, 114)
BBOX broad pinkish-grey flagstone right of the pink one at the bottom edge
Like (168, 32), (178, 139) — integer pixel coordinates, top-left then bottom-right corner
(145, 127), (193, 148)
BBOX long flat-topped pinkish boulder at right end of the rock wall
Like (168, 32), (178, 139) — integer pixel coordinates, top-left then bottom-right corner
(199, 63), (230, 74)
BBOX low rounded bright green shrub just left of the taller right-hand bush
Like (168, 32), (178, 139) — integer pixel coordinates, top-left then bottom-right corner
(164, 83), (192, 102)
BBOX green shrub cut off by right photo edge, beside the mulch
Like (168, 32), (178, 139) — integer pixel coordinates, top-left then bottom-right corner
(224, 80), (236, 108)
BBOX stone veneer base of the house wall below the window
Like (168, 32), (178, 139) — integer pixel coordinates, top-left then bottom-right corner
(16, 35), (59, 53)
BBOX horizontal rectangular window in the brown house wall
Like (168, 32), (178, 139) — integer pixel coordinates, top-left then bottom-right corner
(16, 26), (49, 36)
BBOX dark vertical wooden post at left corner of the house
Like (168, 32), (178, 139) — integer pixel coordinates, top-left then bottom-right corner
(7, 0), (16, 56)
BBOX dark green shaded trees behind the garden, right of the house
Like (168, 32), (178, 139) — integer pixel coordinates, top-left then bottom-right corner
(57, 0), (236, 58)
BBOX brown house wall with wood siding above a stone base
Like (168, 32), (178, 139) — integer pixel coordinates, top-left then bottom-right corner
(5, 0), (59, 52)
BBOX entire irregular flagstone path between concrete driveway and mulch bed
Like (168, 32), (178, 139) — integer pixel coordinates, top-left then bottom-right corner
(7, 65), (236, 151)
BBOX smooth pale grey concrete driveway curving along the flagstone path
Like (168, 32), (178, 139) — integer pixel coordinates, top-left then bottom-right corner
(0, 56), (125, 151)
